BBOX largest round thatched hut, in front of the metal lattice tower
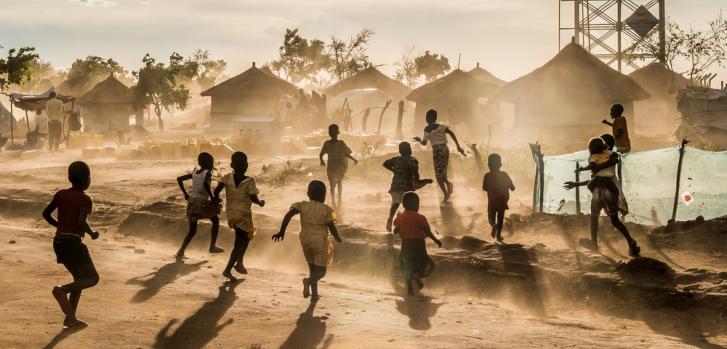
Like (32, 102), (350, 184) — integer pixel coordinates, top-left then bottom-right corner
(490, 42), (649, 148)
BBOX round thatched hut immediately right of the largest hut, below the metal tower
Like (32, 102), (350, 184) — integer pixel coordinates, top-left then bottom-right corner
(629, 62), (689, 136)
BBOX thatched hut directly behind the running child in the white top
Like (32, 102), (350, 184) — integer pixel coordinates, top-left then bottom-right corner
(406, 69), (497, 130)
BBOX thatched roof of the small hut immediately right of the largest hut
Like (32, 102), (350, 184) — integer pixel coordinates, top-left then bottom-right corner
(629, 62), (689, 96)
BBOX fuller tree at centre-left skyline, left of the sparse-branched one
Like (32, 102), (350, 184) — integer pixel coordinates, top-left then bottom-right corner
(270, 29), (331, 84)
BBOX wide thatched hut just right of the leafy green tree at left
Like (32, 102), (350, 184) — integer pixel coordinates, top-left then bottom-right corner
(202, 63), (298, 126)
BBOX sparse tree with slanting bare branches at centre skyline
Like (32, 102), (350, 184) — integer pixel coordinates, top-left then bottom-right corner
(328, 28), (374, 81)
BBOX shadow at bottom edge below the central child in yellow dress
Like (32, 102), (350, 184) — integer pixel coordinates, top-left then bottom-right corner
(280, 302), (333, 349)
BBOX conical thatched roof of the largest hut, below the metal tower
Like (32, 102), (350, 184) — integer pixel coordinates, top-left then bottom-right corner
(492, 42), (649, 104)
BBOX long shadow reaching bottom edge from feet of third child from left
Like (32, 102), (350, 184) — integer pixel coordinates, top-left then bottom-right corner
(153, 280), (242, 349)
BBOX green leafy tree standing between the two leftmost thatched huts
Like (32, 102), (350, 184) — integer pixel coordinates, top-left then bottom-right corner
(133, 53), (190, 131)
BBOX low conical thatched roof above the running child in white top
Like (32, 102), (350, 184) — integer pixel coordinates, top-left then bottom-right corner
(406, 69), (497, 103)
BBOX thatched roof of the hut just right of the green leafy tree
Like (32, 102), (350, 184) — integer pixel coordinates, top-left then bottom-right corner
(202, 63), (298, 97)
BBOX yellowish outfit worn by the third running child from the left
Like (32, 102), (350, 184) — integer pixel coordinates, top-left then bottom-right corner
(222, 173), (260, 239)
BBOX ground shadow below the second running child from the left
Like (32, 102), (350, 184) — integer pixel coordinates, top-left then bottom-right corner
(126, 259), (207, 303)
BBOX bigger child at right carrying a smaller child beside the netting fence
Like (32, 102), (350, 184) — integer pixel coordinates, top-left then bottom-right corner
(564, 138), (641, 257)
